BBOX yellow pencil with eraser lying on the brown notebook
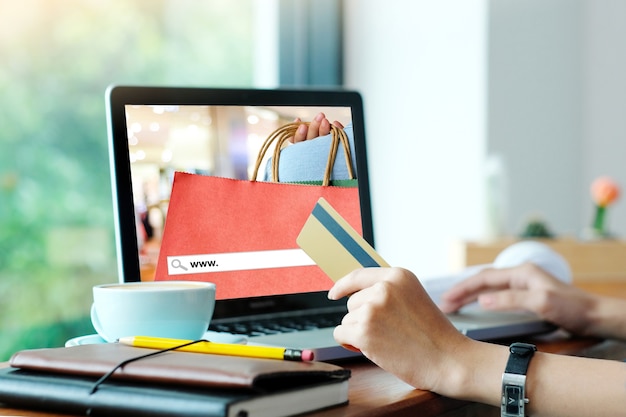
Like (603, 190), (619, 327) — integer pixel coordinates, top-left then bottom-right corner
(118, 336), (314, 361)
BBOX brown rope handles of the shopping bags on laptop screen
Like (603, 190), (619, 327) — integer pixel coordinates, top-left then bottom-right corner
(251, 122), (355, 185)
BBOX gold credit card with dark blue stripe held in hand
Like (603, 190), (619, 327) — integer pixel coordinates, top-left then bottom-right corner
(296, 198), (389, 282)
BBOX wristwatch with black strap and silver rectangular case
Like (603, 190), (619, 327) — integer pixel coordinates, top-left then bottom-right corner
(500, 343), (537, 417)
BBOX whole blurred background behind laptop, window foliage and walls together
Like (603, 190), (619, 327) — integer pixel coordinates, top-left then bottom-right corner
(0, 0), (626, 360)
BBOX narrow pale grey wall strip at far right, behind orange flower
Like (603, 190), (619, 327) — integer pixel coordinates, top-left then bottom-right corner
(580, 0), (626, 234)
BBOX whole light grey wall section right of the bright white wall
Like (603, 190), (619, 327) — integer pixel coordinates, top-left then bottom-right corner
(488, 0), (626, 237)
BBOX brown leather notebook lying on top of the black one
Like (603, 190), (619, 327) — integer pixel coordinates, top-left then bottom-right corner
(10, 343), (350, 392)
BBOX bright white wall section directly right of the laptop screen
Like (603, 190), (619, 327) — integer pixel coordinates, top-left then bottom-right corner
(344, 0), (487, 276)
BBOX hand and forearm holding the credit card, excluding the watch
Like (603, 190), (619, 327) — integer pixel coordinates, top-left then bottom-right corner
(329, 268), (626, 417)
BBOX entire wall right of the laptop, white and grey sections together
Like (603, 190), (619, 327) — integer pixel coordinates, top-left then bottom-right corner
(344, 0), (626, 276)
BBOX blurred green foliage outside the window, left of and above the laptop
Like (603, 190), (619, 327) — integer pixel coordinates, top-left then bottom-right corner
(0, 0), (254, 360)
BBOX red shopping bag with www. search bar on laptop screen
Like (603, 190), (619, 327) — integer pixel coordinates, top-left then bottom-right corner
(155, 172), (362, 299)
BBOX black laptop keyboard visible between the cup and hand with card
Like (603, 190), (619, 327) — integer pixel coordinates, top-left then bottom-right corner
(209, 312), (345, 337)
